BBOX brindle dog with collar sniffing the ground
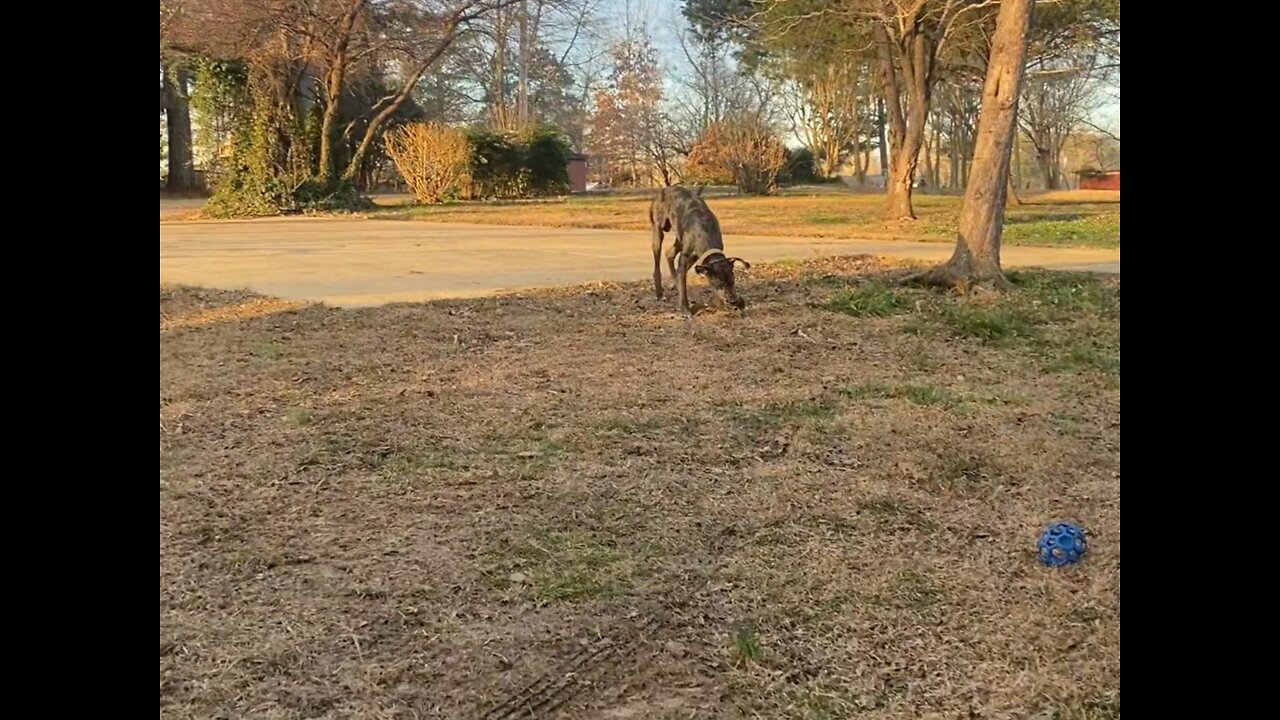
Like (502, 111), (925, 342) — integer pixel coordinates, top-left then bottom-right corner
(649, 186), (751, 316)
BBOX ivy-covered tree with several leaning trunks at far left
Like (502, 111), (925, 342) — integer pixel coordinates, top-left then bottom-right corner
(168, 0), (518, 214)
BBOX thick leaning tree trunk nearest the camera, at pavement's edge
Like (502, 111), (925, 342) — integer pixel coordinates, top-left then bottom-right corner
(915, 0), (1036, 290)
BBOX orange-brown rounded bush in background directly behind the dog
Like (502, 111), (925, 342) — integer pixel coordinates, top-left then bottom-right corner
(689, 122), (786, 195)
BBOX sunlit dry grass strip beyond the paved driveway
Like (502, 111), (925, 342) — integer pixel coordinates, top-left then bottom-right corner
(378, 188), (1120, 247)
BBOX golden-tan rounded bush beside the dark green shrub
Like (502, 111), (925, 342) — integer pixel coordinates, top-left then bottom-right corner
(387, 123), (471, 204)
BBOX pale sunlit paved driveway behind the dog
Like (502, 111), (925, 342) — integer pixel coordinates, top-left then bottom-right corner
(160, 218), (1120, 307)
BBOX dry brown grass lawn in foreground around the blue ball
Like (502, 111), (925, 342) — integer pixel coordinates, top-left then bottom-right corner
(160, 258), (1120, 720)
